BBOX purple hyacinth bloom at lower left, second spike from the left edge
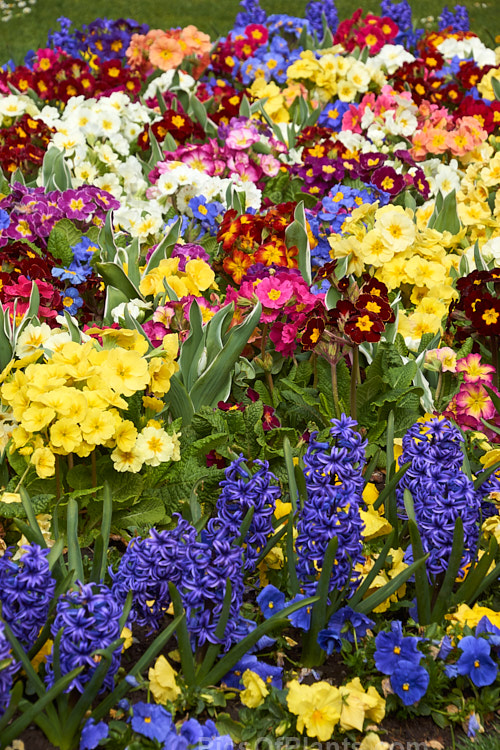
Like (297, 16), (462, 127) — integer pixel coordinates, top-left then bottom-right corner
(45, 581), (123, 693)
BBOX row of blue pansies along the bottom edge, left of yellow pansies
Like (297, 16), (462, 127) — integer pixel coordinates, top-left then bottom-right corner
(80, 701), (234, 750)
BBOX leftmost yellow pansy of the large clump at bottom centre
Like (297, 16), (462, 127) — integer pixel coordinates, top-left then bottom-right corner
(286, 680), (342, 742)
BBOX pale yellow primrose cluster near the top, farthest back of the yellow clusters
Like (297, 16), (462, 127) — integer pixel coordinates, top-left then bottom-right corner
(287, 46), (387, 102)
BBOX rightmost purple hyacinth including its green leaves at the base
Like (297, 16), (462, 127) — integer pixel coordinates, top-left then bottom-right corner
(396, 417), (500, 624)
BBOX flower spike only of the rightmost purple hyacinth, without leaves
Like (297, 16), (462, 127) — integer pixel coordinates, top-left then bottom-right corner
(396, 417), (482, 575)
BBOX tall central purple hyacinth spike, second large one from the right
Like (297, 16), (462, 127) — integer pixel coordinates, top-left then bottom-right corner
(296, 414), (367, 596)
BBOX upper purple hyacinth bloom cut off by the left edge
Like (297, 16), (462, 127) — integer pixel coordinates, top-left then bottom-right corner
(0, 544), (56, 649)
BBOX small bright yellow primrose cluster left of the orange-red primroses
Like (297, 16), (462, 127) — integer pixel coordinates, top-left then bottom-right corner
(139, 258), (216, 298)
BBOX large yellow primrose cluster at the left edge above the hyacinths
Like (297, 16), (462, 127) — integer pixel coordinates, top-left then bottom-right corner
(0, 329), (180, 479)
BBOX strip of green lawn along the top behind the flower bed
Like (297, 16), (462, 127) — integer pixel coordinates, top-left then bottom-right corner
(0, 0), (500, 64)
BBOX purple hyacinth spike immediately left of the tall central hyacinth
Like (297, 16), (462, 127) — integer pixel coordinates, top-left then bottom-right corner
(207, 455), (281, 571)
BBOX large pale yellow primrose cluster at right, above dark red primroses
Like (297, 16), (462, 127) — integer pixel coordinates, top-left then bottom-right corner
(328, 202), (465, 348)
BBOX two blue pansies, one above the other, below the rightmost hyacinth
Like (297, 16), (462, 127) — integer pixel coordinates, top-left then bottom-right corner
(373, 620), (429, 706)
